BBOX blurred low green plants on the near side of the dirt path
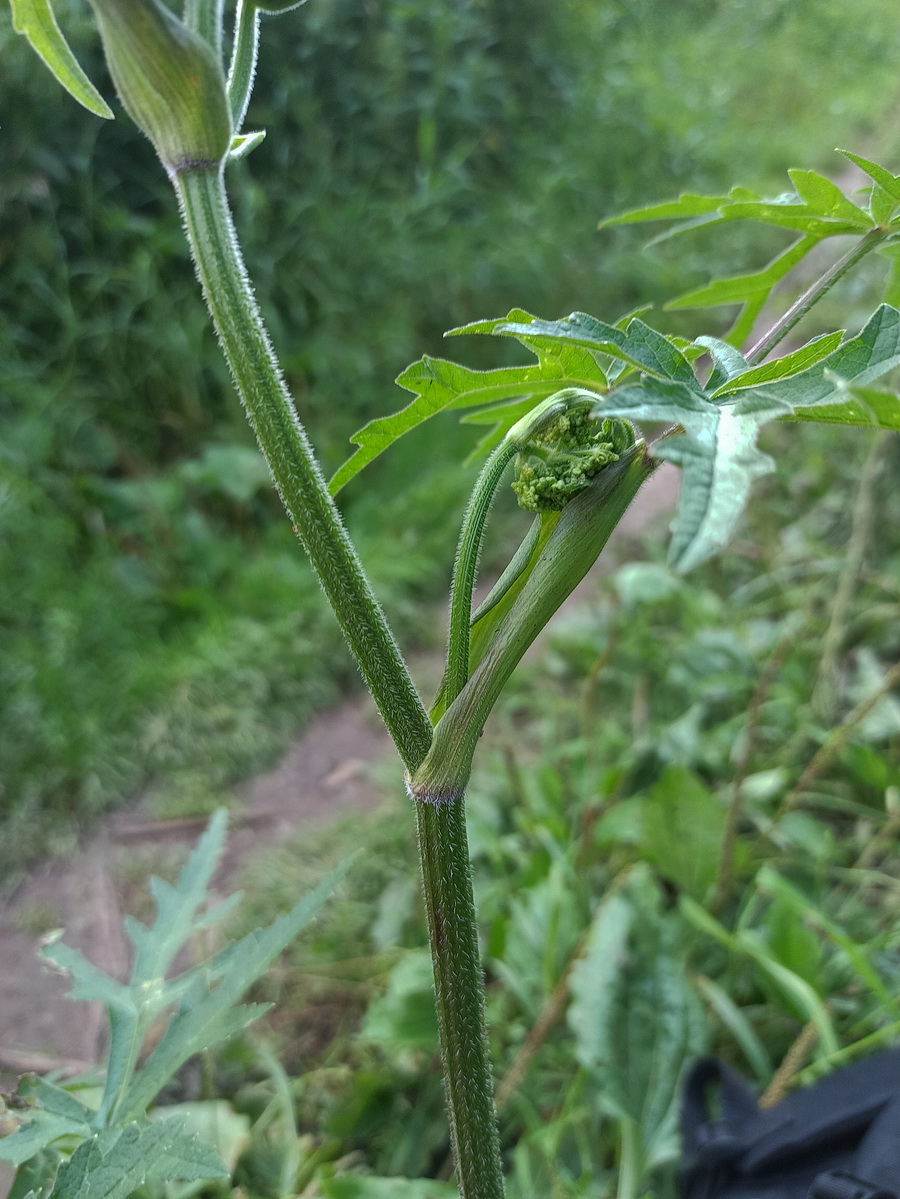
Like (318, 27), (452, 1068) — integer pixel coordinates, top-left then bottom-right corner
(209, 417), (900, 1199)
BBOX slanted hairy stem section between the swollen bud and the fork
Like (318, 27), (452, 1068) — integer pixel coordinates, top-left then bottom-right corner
(173, 169), (431, 769)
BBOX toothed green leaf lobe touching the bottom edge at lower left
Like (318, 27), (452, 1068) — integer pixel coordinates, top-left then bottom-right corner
(49, 1119), (228, 1199)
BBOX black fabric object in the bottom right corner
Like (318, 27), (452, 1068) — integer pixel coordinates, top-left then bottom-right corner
(679, 1049), (900, 1199)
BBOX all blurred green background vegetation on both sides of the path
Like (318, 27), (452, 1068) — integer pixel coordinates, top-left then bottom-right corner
(0, 0), (900, 1199)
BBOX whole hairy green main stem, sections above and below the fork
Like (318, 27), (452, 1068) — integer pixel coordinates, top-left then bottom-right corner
(173, 169), (503, 1199)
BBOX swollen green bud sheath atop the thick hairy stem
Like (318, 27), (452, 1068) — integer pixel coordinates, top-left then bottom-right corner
(91, 0), (231, 174)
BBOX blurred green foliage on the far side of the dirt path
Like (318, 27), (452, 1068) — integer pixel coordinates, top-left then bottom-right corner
(0, 0), (900, 860)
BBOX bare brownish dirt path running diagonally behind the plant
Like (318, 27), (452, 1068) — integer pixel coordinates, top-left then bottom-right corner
(0, 466), (677, 1088)
